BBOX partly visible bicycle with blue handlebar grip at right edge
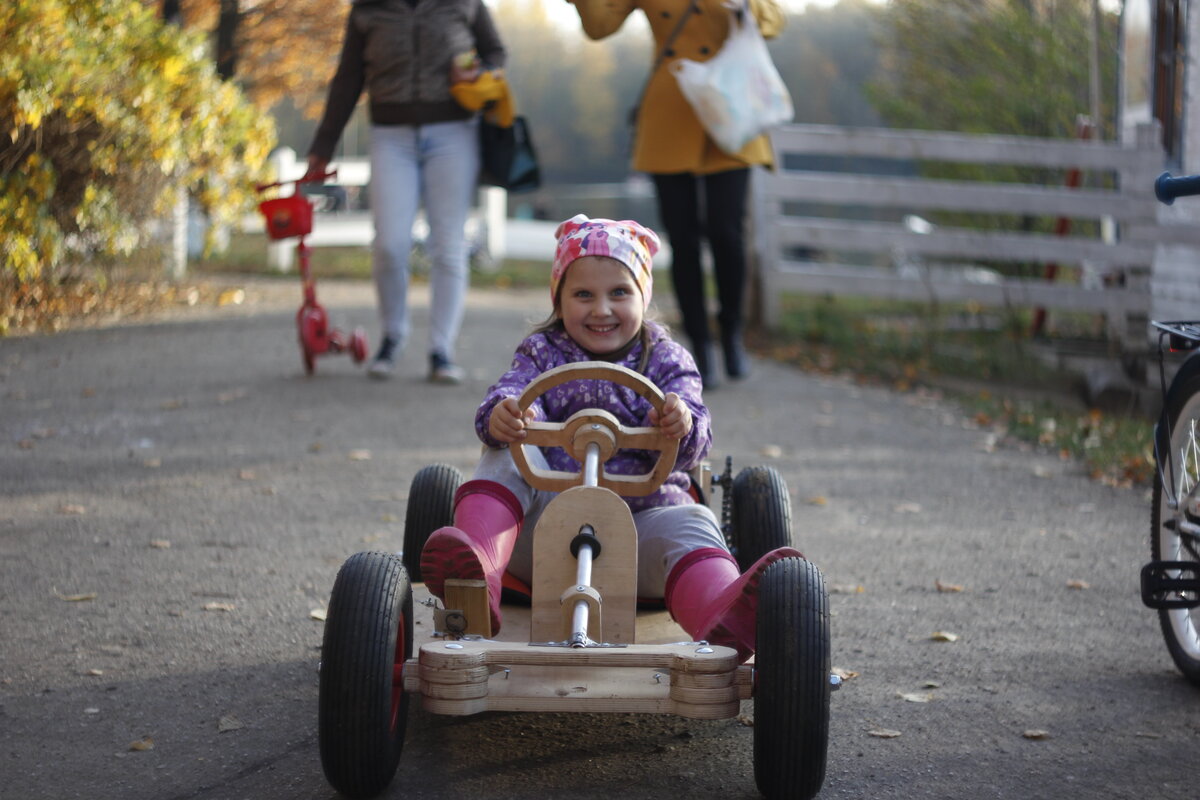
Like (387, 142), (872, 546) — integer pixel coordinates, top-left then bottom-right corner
(1141, 173), (1200, 686)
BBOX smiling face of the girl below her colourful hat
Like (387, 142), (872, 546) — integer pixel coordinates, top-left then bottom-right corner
(557, 255), (642, 355)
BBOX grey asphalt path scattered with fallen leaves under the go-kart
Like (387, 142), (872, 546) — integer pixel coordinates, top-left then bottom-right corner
(0, 282), (1200, 800)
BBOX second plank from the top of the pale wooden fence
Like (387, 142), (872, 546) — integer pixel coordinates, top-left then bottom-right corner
(763, 172), (1156, 222)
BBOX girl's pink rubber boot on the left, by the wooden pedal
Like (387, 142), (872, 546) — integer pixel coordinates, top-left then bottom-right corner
(421, 481), (524, 633)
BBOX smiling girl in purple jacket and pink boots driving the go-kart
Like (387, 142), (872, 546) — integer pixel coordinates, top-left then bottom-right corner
(421, 215), (799, 660)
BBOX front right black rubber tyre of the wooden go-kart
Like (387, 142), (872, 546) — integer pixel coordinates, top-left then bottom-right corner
(754, 558), (832, 800)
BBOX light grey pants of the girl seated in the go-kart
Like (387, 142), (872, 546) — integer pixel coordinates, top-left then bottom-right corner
(474, 447), (728, 599)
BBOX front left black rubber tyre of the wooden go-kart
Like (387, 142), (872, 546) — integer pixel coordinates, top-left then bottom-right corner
(317, 553), (413, 798)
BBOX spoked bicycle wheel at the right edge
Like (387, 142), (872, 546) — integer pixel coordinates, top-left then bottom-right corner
(1150, 372), (1200, 686)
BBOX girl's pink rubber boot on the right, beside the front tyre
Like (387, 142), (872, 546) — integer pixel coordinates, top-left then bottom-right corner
(664, 547), (804, 662)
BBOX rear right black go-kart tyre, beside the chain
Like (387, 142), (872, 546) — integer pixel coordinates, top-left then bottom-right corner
(730, 467), (793, 572)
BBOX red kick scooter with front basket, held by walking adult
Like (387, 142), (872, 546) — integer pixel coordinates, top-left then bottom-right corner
(256, 170), (367, 375)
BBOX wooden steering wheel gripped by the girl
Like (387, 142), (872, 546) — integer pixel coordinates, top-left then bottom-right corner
(509, 361), (679, 498)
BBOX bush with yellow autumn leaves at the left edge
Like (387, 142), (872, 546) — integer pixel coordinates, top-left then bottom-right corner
(0, 0), (275, 281)
